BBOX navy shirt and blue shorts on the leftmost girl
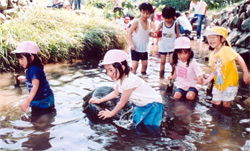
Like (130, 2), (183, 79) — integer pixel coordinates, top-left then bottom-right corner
(25, 65), (54, 108)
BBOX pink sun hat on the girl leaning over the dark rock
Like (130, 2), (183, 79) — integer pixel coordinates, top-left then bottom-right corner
(100, 49), (128, 65)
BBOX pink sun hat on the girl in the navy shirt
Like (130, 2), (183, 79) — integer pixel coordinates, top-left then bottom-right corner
(11, 41), (39, 54)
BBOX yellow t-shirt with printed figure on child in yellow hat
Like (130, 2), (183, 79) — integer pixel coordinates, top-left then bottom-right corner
(209, 46), (239, 91)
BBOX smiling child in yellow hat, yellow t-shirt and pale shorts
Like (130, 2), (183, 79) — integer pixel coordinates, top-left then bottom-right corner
(204, 26), (250, 108)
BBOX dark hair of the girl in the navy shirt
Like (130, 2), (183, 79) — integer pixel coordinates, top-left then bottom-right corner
(16, 53), (43, 69)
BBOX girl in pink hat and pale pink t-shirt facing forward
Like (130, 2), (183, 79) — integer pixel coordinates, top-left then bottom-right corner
(168, 37), (203, 100)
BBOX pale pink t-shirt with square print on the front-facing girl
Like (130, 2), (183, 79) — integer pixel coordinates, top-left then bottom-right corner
(176, 59), (204, 91)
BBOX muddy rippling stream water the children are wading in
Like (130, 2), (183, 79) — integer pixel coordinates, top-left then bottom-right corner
(0, 42), (250, 151)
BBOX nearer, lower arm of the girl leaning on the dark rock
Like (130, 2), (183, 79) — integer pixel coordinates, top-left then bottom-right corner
(98, 88), (136, 120)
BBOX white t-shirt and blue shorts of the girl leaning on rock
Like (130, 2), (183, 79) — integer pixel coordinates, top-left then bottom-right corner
(117, 73), (163, 128)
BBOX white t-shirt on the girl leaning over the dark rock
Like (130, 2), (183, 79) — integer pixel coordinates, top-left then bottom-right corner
(117, 73), (162, 106)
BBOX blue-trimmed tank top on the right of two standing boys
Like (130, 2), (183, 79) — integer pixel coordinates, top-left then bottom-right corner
(159, 22), (176, 53)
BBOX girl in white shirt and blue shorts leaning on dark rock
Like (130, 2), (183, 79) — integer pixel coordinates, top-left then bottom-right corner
(89, 49), (163, 134)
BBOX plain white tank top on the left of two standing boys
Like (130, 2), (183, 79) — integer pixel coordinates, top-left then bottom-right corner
(132, 19), (150, 52)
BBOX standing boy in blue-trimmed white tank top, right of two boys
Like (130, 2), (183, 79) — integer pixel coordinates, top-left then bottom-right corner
(155, 7), (179, 78)
